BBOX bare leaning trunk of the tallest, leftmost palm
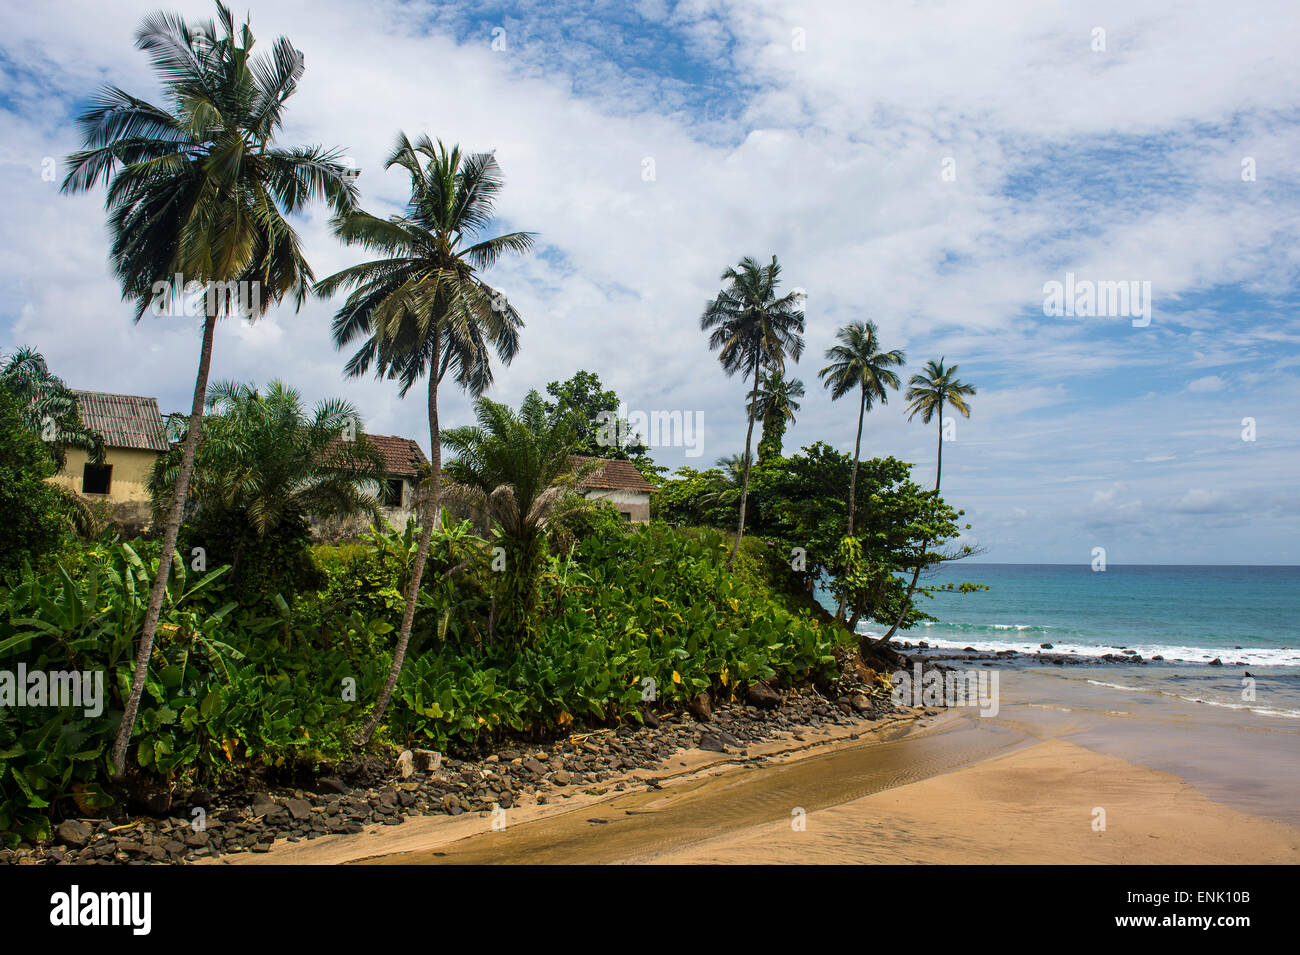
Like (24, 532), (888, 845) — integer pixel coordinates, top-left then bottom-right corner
(113, 314), (217, 776)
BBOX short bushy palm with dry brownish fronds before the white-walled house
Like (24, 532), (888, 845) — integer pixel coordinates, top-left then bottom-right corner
(442, 391), (601, 642)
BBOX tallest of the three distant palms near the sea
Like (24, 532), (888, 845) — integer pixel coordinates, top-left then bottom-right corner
(699, 256), (803, 570)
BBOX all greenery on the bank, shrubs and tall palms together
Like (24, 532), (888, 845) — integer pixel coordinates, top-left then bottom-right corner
(0, 4), (974, 845)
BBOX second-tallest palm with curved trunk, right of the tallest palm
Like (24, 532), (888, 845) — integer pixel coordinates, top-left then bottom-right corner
(317, 134), (533, 746)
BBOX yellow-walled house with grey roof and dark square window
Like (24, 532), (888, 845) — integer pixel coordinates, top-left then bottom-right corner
(51, 391), (168, 534)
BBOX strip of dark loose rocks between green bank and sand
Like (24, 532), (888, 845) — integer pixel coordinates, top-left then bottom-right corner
(0, 660), (896, 865)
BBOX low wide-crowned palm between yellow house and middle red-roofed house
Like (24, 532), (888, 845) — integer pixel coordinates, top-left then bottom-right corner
(148, 381), (384, 578)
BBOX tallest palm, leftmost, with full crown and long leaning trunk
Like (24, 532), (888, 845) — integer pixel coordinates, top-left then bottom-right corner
(62, 3), (356, 773)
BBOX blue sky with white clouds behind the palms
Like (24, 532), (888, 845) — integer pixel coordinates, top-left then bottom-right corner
(0, 0), (1300, 564)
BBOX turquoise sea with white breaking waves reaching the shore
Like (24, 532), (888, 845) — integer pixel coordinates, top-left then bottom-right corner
(820, 563), (1300, 717)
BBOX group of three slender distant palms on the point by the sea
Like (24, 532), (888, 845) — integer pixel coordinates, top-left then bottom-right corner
(699, 256), (975, 628)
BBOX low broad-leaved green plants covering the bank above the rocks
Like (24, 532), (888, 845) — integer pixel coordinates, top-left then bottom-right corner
(0, 515), (844, 842)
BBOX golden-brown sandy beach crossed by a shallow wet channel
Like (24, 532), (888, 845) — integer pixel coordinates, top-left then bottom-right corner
(215, 669), (1300, 864)
